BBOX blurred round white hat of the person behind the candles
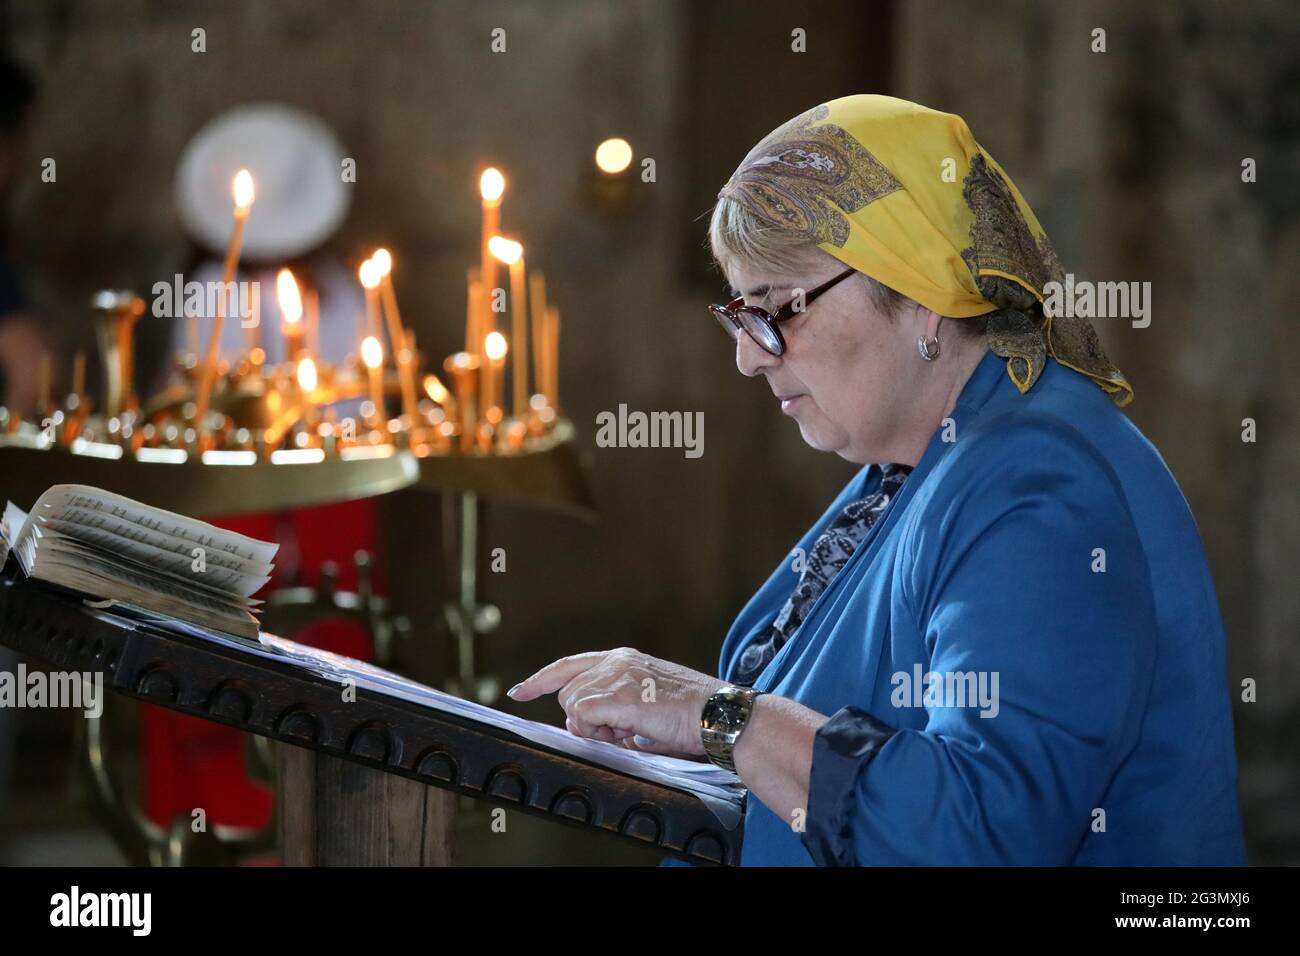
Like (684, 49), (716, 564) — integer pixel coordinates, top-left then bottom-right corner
(176, 103), (352, 260)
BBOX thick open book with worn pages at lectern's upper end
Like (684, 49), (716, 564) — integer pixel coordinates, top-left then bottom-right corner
(0, 485), (280, 641)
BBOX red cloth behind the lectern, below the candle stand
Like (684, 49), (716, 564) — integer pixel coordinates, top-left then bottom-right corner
(139, 498), (386, 827)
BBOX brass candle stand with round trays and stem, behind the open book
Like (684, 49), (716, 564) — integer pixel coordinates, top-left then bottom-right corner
(0, 291), (595, 702)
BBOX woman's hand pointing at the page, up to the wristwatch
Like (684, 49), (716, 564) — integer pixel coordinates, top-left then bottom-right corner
(507, 648), (727, 757)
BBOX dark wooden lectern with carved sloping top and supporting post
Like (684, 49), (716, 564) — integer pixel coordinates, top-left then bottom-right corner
(0, 562), (742, 866)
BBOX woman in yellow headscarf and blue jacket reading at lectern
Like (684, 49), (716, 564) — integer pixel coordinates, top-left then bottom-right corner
(511, 96), (1244, 865)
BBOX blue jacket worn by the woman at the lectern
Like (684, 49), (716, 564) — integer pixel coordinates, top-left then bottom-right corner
(676, 354), (1244, 866)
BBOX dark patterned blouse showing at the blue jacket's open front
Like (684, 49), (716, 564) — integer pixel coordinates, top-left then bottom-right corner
(729, 464), (911, 687)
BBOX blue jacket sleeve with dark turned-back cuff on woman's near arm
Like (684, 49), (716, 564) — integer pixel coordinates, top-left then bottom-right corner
(802, 419), (1156, 865)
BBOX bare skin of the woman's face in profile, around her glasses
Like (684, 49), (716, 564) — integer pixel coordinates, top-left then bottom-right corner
(728, 250), (935, 464)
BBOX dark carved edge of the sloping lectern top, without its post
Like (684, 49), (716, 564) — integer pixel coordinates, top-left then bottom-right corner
(0, 564), (744, 865)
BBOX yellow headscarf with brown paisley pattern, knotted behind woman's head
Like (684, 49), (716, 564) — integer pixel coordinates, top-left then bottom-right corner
(718, 94), (1134, 406)
